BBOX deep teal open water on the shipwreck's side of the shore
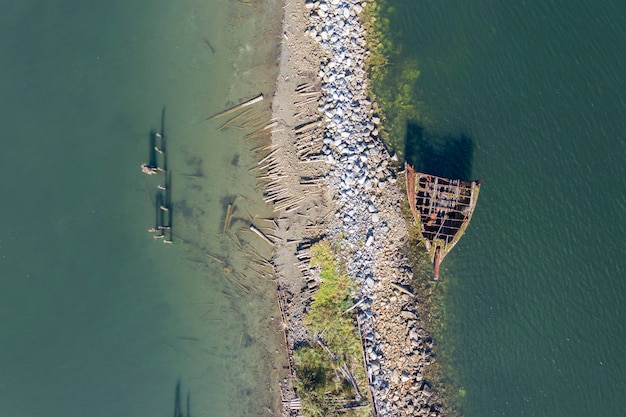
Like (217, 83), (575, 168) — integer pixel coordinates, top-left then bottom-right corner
(391, 0), (626, 417)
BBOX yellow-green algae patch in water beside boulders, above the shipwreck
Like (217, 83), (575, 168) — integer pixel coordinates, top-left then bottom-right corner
(362, 0), (423, 160)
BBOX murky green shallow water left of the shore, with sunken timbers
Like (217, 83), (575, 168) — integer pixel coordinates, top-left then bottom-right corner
(0, 0), (282, 417)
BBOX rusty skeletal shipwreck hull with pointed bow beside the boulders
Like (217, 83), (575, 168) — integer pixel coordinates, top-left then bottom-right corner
(405, 163), (482, 279)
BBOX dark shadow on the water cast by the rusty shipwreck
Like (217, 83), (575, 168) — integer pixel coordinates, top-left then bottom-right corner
(404, 121), (474, 181)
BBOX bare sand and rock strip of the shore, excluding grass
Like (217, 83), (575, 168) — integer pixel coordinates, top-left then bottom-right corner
(265, 0), (445, 417)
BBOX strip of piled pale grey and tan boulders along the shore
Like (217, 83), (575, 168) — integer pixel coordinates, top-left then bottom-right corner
(307, 0), (442, 416)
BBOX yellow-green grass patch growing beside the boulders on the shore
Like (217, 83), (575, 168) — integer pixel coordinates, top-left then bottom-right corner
(294, 241), (372, 417)
